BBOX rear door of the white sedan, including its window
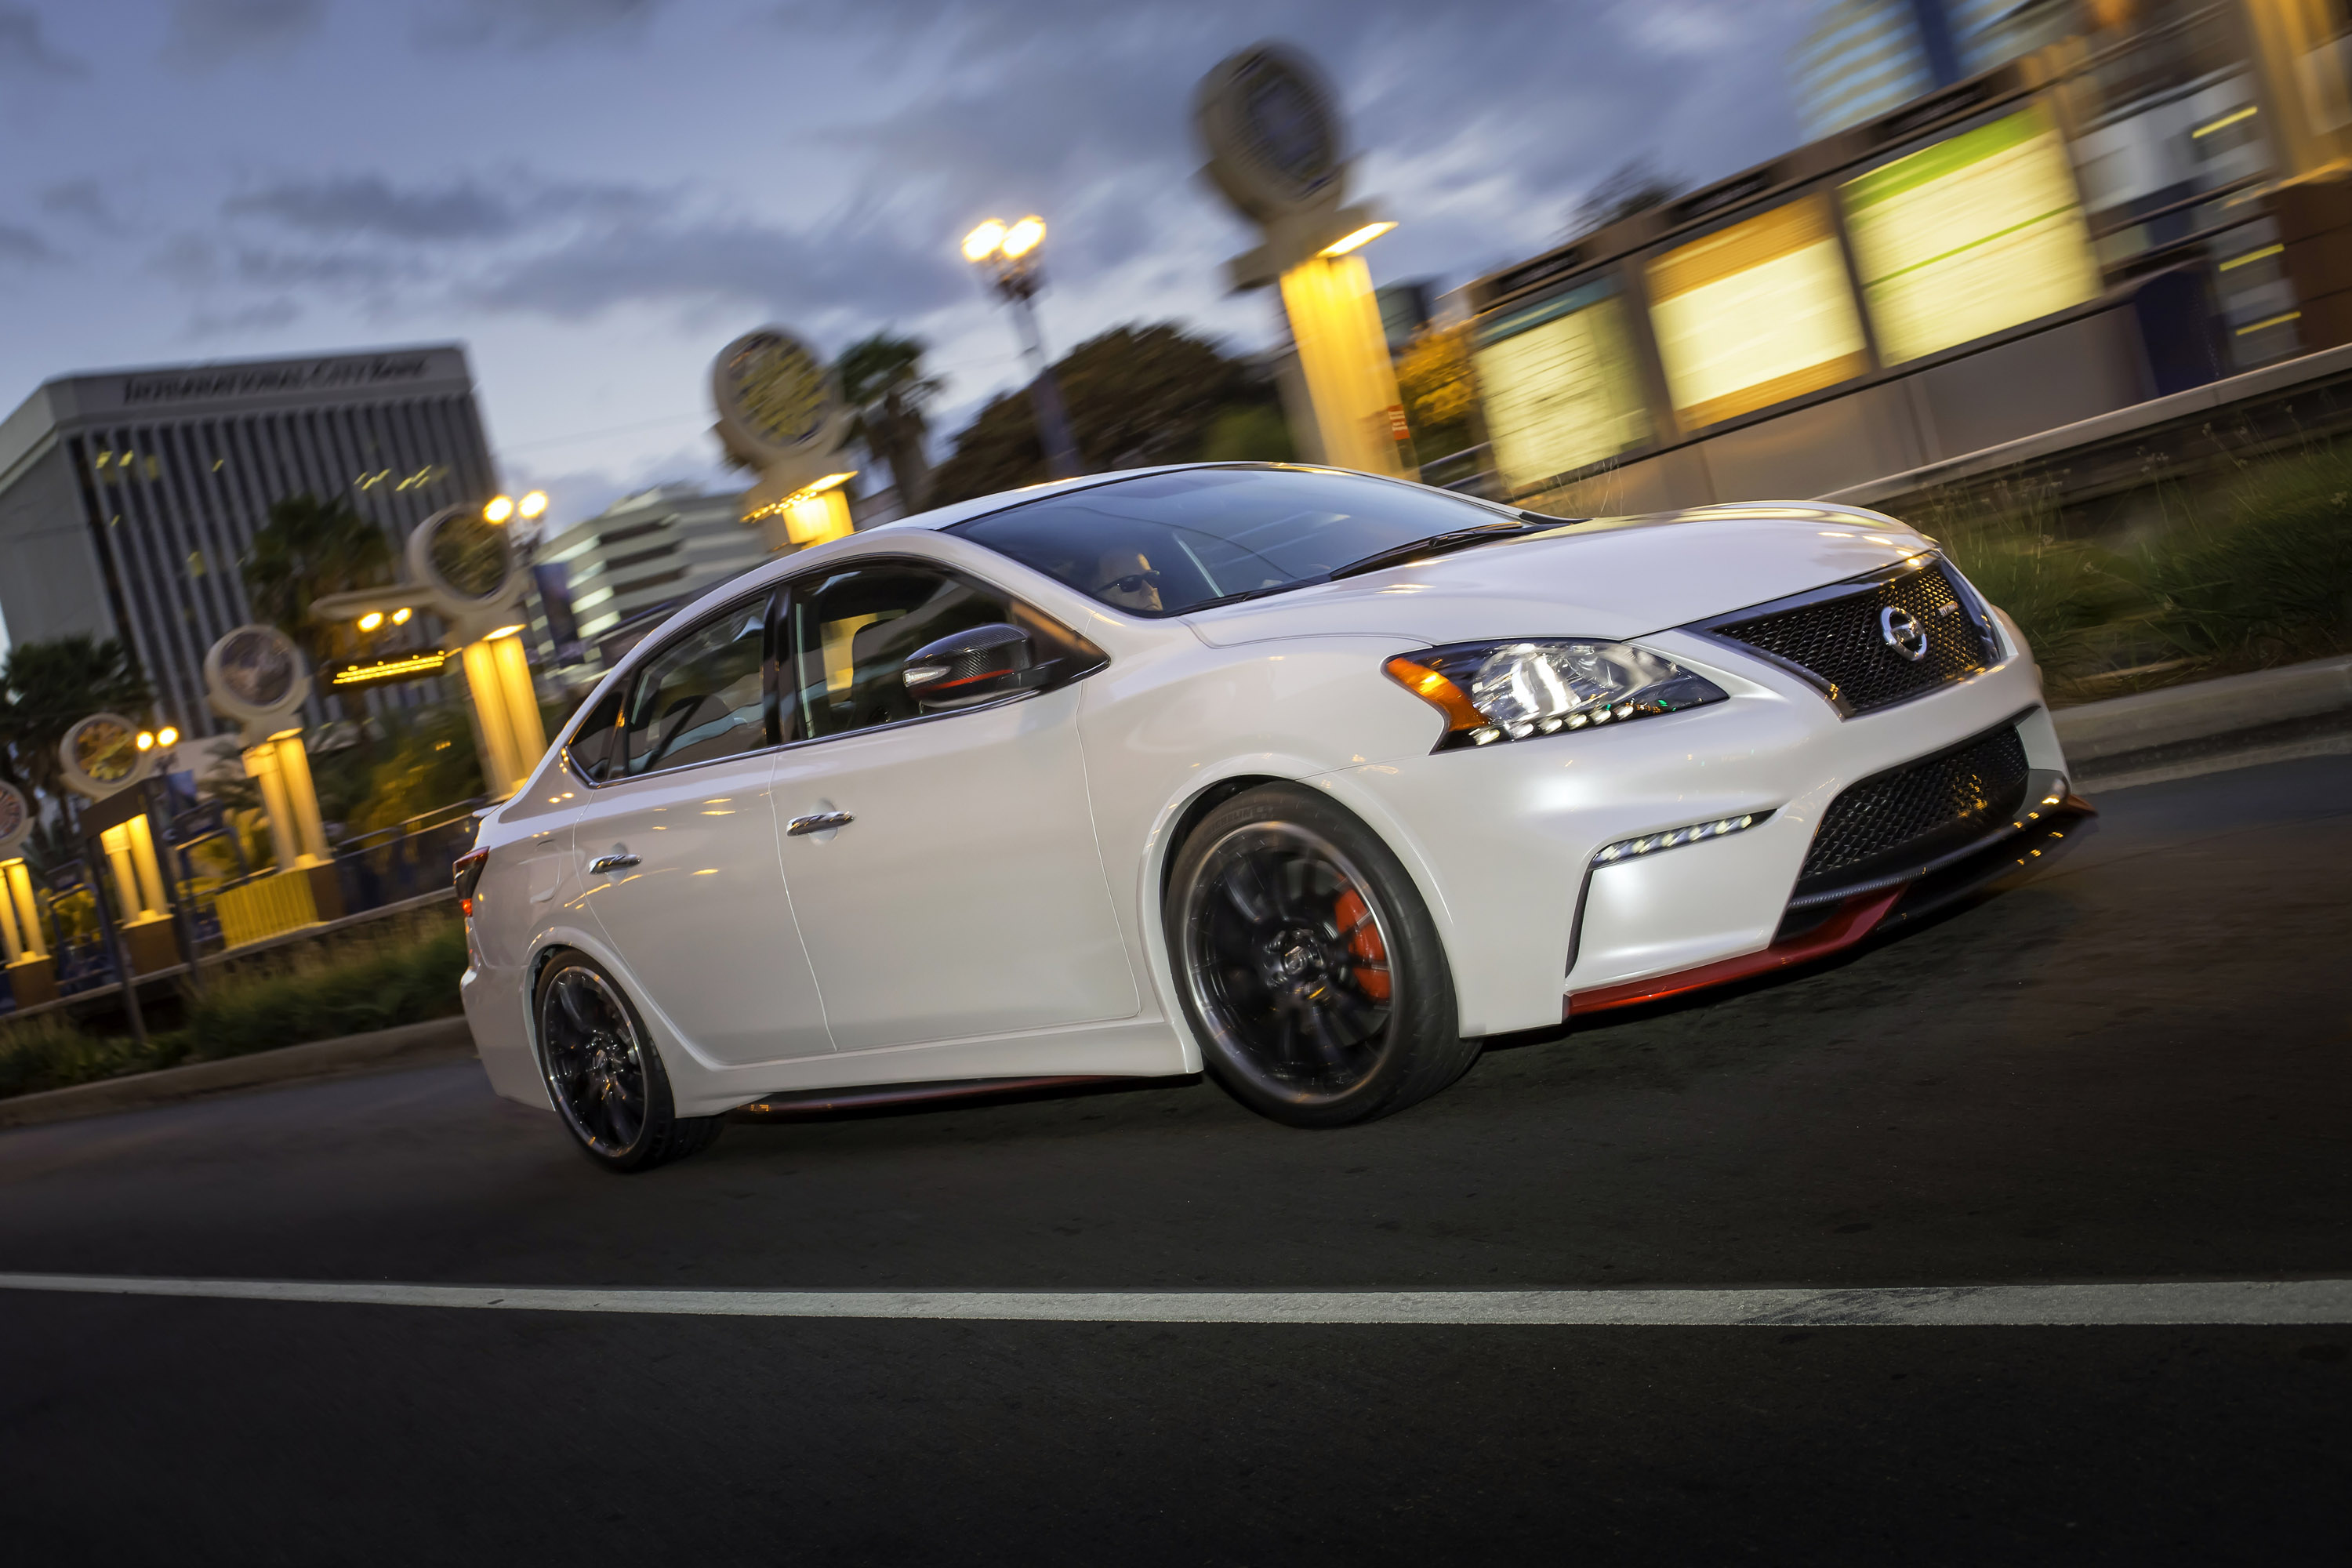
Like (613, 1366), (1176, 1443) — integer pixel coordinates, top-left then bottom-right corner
(574, 593), (833, 1067)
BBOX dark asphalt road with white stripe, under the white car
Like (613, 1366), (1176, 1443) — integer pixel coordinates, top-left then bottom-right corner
(0, 757), (2352, 1563)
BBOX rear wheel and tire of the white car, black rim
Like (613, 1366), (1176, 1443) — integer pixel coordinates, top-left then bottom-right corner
(532, 952), (724, 1173)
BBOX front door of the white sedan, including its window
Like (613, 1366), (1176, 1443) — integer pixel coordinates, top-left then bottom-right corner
(774, 560), (1138, 1051)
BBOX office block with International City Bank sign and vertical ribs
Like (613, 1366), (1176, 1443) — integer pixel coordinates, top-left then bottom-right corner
(0, 343), (496, 736)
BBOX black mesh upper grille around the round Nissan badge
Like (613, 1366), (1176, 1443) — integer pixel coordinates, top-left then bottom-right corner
(1705, 557), (1994, 717)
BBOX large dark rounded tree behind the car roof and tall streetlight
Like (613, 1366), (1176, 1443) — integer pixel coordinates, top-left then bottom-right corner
(931, 322), (1277, 506)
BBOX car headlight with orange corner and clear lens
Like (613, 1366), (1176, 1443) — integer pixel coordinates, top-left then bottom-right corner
(1385, 642), (1729, 750)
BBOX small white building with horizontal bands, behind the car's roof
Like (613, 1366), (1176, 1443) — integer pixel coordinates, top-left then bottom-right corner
(532, 485), (767, 654)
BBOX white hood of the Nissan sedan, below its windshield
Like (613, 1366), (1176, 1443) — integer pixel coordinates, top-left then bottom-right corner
(1185, 503), (1933, 647)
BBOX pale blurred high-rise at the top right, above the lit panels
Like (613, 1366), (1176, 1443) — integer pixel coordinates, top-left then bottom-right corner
(1792, 0), (2082, 136)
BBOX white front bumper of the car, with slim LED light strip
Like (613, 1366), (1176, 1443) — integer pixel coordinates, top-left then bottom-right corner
(1317, 633), (2065, 1034)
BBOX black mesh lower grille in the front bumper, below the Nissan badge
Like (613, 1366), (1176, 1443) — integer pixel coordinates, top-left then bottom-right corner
(1797, 727), (2025, 893)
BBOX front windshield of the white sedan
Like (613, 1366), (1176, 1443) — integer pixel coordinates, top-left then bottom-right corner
(948, 468), (1512, 616)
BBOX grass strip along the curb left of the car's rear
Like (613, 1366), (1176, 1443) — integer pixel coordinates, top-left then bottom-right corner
(0, 924), (466, 1098)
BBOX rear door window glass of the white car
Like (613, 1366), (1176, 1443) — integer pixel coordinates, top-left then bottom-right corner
(619, 595), (769, 779)
